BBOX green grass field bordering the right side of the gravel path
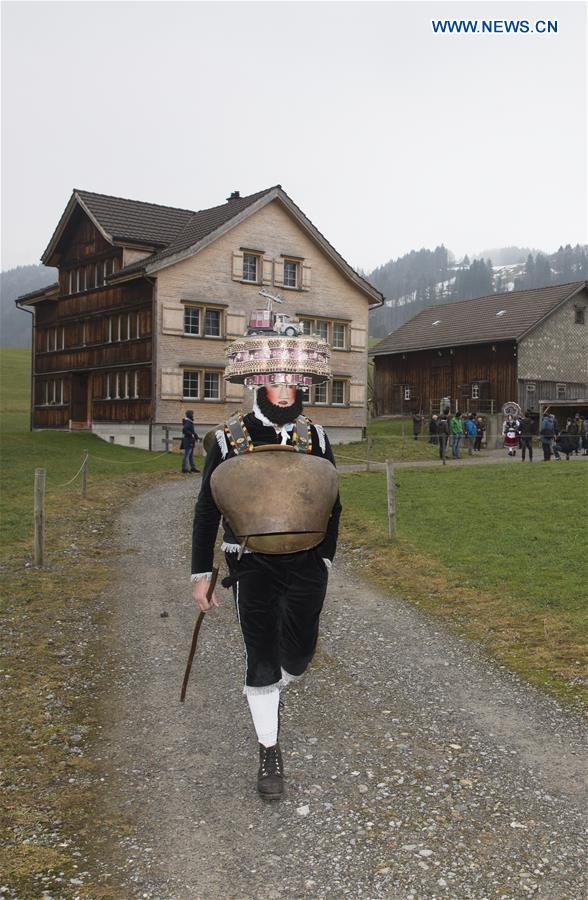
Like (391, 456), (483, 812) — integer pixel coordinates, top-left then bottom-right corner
(341, 463), (588, 701)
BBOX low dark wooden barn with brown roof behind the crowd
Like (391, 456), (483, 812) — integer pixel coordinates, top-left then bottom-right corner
(370, 281), (588, 416)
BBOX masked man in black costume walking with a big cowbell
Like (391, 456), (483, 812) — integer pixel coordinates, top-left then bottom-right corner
(192, 320), (341, 800)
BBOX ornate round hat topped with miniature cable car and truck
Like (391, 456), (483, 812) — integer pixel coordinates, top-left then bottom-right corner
(225, 290), (332, 388)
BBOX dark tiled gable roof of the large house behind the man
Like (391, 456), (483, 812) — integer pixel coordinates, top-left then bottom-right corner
(41, 184), (384, 306)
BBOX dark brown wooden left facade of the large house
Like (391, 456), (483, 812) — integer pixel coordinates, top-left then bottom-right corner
(32, 214), (153, 428)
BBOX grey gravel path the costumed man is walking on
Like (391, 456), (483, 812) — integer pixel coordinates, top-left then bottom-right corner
(94, 478), (587, 900)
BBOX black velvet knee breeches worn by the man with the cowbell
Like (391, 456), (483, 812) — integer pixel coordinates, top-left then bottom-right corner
(226, 550), (329, 687)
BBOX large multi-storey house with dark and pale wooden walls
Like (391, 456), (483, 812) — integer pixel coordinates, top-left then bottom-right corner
(16, 185), (383, 450)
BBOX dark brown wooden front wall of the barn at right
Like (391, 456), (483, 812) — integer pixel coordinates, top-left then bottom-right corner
(373, 341), (517, 416)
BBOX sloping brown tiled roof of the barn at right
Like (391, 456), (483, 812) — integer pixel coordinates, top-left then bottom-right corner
(370, 281), (588, 356)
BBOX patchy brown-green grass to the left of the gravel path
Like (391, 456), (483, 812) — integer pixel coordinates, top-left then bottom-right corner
(0, 350), (186, 898)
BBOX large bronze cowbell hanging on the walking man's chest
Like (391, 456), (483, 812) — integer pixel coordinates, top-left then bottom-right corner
(210, 444), (338, 554)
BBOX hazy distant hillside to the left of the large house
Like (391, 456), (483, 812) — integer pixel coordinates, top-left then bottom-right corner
(0, 266), (57, 347)
